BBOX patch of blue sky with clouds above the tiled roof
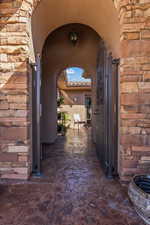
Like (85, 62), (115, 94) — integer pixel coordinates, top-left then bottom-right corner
(67, 67), (91, 82)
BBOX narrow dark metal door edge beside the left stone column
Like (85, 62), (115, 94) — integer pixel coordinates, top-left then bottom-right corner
(32, 56), (41, 175)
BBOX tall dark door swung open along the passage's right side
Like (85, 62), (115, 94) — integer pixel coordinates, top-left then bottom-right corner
(96, 42), (118, 178)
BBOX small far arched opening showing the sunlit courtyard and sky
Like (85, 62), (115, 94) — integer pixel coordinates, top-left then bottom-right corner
(57, 67), (92, 133)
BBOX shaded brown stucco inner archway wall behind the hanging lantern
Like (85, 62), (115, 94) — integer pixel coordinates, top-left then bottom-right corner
(39, 24), (101, 143)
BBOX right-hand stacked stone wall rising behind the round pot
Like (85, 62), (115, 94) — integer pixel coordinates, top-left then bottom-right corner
(118, 0), (150, 180)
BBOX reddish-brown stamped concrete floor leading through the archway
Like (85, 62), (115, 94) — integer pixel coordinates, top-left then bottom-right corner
(0, 130), (144, 225)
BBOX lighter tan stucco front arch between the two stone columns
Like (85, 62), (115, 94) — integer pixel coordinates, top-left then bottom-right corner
(32, 0), (120, 57)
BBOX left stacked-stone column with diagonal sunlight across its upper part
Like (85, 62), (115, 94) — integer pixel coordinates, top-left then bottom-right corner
(0, 0), (37, 179)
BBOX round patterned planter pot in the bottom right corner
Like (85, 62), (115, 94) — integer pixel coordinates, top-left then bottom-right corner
(128, 175), (150, 224)
